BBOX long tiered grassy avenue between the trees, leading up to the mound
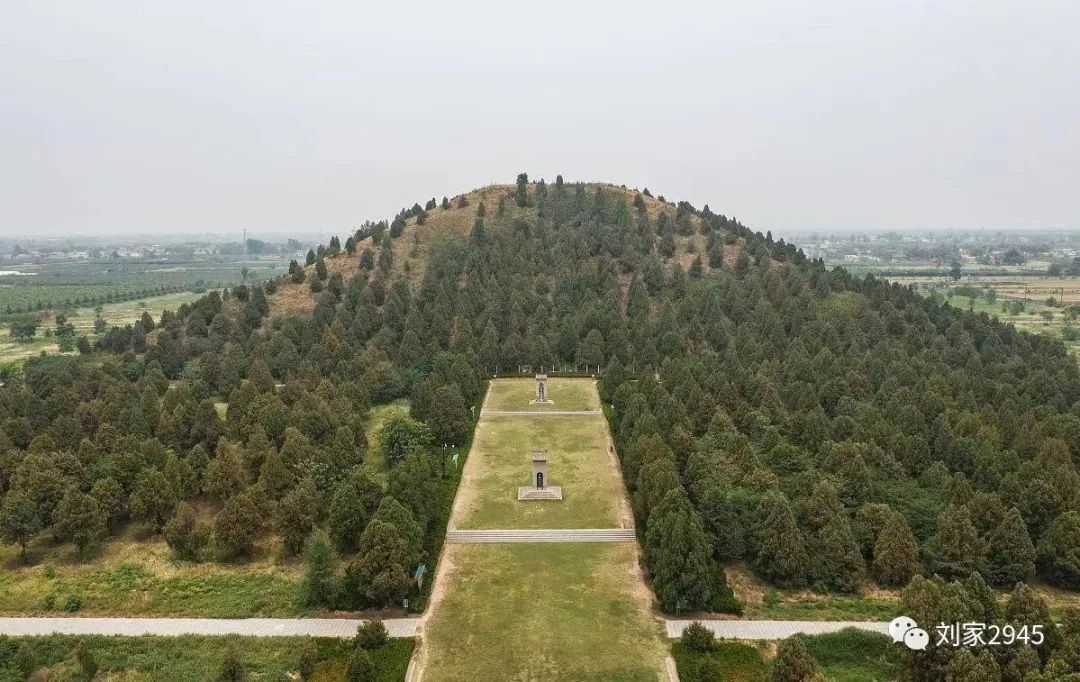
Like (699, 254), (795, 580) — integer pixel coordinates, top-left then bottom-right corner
(417, 378), (669, 682)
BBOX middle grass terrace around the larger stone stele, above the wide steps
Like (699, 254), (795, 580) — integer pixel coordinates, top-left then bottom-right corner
(454, 412), (622, 529)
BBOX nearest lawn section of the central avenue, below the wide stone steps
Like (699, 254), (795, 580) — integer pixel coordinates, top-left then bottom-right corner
(423, 543), (667, 682)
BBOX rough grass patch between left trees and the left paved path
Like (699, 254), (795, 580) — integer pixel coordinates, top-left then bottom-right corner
(0, 531), (303, 618)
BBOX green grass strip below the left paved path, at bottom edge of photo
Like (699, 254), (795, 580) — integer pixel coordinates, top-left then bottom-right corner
(0, 634), (414, 682)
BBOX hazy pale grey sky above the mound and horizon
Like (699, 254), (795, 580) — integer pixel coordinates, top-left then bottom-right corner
(0, 0), (1080, 237)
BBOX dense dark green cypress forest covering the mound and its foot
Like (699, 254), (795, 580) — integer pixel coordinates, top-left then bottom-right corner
(0, 174), (1080, 679)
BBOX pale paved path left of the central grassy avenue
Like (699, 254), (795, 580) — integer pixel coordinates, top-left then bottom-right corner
(0, 618), (420, 638)
